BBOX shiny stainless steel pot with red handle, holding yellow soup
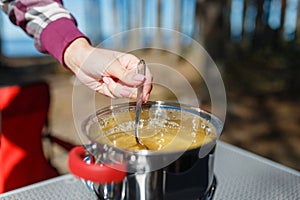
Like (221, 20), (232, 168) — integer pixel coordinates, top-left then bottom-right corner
(69, 101), (222, 200)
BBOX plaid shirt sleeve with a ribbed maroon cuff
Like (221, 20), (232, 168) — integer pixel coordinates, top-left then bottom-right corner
(0, 0), (86, 64)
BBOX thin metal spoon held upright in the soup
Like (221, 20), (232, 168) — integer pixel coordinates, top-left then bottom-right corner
(134, 60), (149, 149)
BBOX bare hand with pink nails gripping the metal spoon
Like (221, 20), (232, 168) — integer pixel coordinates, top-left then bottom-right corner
(64, 38), (152, 101)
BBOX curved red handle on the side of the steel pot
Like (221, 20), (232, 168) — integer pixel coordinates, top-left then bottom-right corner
(68, 146), (126, 184)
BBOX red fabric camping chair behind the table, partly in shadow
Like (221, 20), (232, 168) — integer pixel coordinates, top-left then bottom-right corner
(0, 82), (58, 193)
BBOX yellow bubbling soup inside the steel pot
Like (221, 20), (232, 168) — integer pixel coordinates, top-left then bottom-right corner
(90, 110), (216, 151)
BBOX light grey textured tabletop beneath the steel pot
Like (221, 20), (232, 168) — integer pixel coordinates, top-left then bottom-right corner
(0, 142), (300, 200)
